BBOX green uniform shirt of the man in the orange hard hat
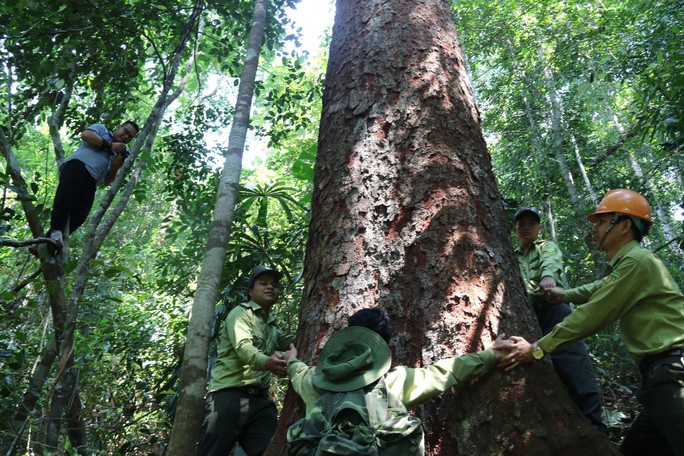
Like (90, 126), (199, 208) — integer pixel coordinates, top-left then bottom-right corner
(539, 241), (684, 361)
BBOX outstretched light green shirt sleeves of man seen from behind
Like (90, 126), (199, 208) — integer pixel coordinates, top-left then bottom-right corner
(287, 350), (496, 413)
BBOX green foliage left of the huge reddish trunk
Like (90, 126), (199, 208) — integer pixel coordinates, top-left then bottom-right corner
(0, 0), (320, 454)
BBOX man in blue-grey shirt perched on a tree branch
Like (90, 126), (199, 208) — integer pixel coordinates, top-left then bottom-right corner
(50, 120), (139, 252)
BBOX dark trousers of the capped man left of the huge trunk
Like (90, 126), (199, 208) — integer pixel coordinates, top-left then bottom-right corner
(197, 388), (278, 456)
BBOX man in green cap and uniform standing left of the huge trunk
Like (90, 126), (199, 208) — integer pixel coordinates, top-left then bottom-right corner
(198, 265), (294, 456)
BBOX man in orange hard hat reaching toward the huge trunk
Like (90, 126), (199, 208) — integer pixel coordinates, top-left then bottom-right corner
(504, 189), (684, 456)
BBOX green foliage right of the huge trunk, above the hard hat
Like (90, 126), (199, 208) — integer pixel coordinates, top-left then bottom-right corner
(455, 0), (684, 284)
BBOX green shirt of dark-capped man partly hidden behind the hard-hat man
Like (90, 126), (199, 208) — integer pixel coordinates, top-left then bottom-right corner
(515, 239), (563, 304)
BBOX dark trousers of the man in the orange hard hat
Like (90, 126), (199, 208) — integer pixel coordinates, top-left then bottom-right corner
(620, 355), (684, 456)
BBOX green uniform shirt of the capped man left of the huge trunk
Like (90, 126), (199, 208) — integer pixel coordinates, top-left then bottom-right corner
(209, 301), (294, 393)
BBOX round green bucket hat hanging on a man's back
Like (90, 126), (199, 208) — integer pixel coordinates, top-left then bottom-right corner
(313, 326), (392, 392)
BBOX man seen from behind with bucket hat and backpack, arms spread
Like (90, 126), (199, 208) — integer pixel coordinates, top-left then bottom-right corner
(285, 307), (508, 456)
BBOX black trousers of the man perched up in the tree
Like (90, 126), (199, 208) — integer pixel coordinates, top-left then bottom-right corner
(50, 160), (97, 233)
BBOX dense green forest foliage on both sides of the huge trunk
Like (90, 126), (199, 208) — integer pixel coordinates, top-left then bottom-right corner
(0, 0), (684, 454)
